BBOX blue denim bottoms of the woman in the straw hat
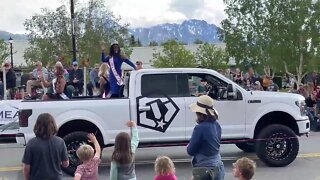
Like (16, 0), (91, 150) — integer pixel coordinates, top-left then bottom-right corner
(192, 162), (225, 180)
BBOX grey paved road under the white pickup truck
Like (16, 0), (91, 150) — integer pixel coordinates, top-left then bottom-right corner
(0, 133), (320, 180)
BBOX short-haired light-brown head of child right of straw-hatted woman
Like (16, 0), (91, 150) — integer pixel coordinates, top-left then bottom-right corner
(233, 157), (256, 180)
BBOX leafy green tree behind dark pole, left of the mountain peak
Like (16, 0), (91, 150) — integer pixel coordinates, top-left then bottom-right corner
(24, 0), (132, 65)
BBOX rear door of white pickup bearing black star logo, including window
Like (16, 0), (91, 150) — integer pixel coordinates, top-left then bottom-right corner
(135, 73), (188, 142)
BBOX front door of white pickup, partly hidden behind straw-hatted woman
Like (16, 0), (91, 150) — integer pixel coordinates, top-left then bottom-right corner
(185, 73), (246, 139)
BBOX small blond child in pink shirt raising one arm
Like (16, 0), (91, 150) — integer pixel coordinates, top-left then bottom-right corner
(74, 133), (101, 180)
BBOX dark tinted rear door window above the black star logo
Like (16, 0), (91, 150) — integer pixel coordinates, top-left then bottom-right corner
(141, 74), (189, 97)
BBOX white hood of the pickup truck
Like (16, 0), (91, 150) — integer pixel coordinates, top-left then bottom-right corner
(249, 91), (305, 101)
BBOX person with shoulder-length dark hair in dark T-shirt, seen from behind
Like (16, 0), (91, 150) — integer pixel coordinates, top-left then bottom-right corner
(22, 113), (69, 180)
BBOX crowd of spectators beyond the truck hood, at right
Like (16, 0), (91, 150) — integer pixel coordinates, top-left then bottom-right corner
(219, 67), (320, 131)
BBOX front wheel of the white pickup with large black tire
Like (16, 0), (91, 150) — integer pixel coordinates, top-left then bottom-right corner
(255, 124), (299, 167)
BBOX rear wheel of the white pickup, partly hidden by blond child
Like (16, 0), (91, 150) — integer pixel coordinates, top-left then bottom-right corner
(62, 131), (89, 176)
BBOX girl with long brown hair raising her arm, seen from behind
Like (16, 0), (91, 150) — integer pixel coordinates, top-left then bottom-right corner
(110, 121), (139, 180)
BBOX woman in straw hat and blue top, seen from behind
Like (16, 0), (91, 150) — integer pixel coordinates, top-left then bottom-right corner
(187, 95), (225, 180)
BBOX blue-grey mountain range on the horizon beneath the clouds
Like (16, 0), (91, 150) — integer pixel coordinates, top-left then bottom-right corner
(0, 19), (220, 45)
